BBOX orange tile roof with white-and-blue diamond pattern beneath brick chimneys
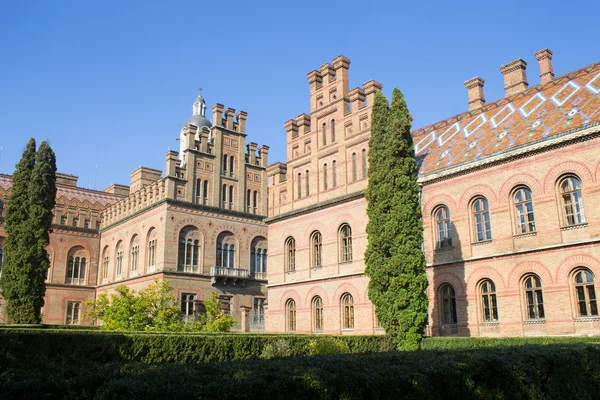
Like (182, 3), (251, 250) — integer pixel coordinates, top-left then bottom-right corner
(412, 63), (600, 176)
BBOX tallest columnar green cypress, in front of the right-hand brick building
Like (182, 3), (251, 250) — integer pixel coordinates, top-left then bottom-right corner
(365, 88), (427, 350)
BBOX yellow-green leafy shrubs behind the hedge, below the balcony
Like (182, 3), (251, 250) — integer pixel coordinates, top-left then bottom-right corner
(85, 279), (235, 332)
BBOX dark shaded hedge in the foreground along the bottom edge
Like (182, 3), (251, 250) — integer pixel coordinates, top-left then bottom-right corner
(0, 344), (600, 400)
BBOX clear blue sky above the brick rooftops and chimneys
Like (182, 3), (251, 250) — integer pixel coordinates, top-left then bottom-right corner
(0, 0), (600, 189)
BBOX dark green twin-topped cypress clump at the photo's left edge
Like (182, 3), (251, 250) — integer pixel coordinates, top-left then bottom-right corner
(0, 138), (56, 324)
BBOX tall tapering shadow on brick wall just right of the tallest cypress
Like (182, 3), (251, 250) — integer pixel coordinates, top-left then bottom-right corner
(430, 222), (470, 336)
